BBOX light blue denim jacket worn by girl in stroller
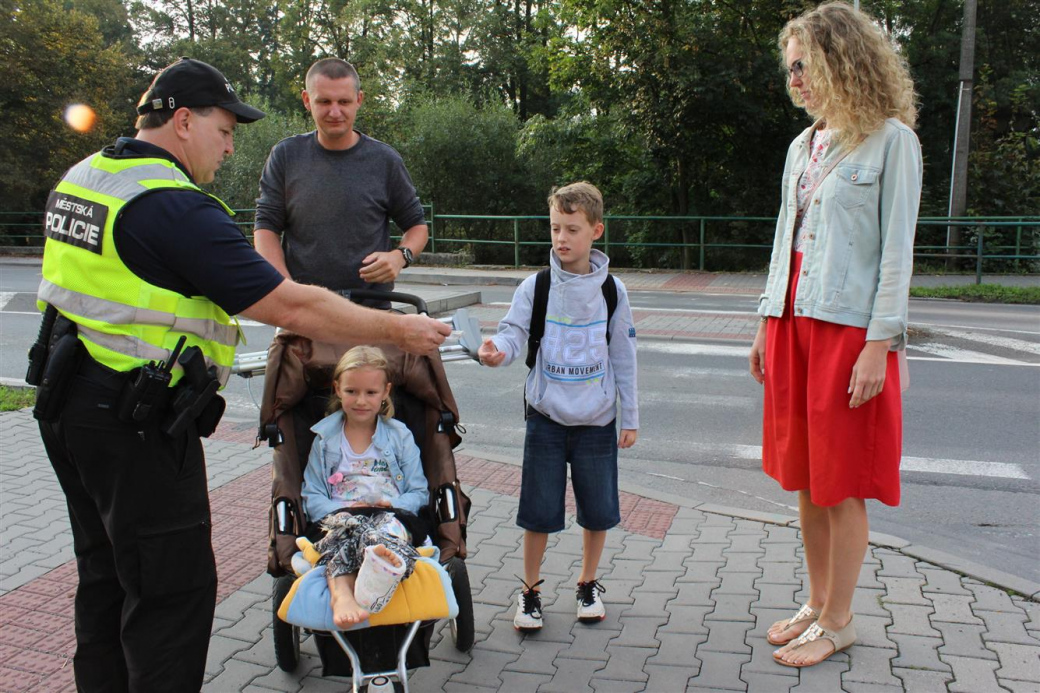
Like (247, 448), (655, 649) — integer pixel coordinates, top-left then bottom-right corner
(303, 411), (430, 522)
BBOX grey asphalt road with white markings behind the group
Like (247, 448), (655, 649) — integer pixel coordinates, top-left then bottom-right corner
(0, 262), (1040, 582)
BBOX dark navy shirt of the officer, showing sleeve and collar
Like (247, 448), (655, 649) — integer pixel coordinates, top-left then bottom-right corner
(114, 139), (284, 315)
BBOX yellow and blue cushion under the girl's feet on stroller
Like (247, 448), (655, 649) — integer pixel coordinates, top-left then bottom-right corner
(278, 538), (459, 631)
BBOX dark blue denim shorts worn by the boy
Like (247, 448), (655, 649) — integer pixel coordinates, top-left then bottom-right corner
(517, 410), (621, 534)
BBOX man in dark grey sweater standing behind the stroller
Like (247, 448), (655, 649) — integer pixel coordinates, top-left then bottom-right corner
(254, 58), (428, 307)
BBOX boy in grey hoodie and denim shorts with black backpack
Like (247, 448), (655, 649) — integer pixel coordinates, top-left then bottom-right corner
(478, 182), (640, 631)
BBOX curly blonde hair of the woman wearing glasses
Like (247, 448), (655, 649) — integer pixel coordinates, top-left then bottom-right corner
(779, 2), (917, 145)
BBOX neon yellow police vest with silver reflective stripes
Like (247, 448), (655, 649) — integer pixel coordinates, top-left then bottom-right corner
(38, 153), (240, 385)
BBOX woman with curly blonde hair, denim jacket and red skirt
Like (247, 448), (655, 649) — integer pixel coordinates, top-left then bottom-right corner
(749, 2), (922, 667)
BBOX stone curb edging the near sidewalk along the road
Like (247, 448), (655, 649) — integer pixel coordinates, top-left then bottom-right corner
(457, 445), (1040, 602)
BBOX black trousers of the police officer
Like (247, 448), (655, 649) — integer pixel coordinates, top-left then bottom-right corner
(40, 362), (216, 693)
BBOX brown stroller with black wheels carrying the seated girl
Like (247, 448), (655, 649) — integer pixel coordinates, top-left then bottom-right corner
(238, 290), (479, 690)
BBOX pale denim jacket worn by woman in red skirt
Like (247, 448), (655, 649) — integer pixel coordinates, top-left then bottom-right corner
(758, 119), (922, 351)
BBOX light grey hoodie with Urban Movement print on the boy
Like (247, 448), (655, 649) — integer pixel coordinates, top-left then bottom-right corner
(492, 250), (640, 429)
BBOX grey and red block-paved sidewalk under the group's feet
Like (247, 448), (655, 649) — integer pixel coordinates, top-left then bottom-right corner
(0, 410), (1040, 693)
